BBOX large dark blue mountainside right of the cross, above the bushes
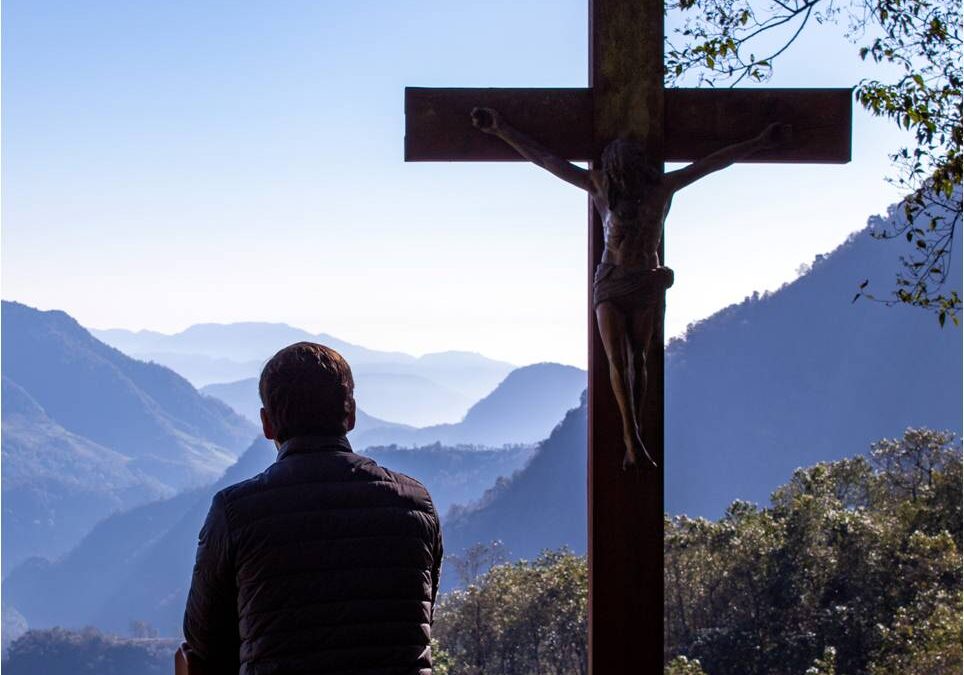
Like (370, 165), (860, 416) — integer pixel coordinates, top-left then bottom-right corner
(666, 211), (964, 518)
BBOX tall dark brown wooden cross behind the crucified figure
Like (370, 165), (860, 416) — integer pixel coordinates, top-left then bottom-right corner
(405, 0), (851, 675)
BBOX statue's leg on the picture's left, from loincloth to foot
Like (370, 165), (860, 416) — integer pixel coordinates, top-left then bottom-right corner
(596, 302), (645, 468)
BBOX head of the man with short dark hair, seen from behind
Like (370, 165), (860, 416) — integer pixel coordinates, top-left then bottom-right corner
(258, 342), (355, 443)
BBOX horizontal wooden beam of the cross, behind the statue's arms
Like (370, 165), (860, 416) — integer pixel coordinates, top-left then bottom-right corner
(405, 87), (852, 164)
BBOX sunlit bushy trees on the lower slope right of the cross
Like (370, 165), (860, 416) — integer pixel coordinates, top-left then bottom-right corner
(664, 429), (962, 675)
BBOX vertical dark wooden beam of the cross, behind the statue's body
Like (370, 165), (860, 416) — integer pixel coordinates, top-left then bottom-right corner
(588, 0), (663, 675)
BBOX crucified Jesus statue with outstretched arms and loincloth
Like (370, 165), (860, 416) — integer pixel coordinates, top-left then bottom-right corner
(472, 108), (791, 469)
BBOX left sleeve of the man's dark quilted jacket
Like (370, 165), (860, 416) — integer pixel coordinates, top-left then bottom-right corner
(184, 493), (240, 674)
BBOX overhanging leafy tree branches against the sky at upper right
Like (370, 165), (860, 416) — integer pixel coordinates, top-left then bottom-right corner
(666, 0), (962, 326)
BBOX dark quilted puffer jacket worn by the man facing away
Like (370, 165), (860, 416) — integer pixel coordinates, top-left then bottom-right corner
(184, 437), (442, 675)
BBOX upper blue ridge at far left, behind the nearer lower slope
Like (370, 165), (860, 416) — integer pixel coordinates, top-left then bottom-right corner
(3, 302), (256, 487)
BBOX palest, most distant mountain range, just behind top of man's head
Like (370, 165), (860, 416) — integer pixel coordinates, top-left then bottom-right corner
(91, 322), (514, 426)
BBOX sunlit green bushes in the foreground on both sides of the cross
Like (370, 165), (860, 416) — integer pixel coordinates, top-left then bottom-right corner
(433, 429), (962, 675)
